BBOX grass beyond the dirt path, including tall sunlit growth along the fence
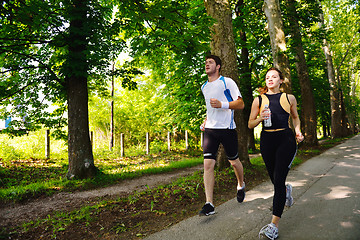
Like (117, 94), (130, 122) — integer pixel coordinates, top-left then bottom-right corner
(0, 130), (202, 203)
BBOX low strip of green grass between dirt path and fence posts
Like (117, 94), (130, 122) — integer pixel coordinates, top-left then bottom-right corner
(0, 153), (203, 202)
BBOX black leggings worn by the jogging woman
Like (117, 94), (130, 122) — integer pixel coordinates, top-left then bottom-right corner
(260, 129), (297, 217)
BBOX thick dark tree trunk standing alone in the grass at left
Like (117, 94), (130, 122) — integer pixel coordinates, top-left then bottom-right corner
(65, 0), (97, 179)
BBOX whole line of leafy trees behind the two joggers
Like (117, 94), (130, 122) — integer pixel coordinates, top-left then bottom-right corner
(0, 0), (360, 178)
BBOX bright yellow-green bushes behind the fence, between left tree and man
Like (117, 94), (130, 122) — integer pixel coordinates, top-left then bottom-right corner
(89, 69), (204, 150)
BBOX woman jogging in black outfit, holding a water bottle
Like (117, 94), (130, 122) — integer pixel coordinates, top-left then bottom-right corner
(248, 68), (304, 239)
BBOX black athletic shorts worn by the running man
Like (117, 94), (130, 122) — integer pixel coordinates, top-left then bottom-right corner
(203, 128), (239, 160)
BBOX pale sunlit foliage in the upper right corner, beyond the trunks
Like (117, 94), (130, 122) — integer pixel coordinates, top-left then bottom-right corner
(322, 0), (360, 127)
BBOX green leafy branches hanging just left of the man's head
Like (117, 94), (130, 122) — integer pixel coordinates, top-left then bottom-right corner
(112, 0), (211, 131)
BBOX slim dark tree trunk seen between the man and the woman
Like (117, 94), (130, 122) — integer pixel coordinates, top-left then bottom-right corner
(235, 0), (256, 151)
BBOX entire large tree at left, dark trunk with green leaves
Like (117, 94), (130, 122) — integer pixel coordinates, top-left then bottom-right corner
(0, 0), (122, 179)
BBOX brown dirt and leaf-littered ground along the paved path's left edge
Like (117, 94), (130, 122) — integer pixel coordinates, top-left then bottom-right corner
(0, 142), (339, 239)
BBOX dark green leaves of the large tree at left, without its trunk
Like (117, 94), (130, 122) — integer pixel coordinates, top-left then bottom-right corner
(0, 0), (124, 137)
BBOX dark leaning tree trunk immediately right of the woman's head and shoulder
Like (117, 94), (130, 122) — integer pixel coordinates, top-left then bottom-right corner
(287, 0), (318, 146)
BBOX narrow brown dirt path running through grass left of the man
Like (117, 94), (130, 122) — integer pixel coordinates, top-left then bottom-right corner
(0, 165), (203, 226)
